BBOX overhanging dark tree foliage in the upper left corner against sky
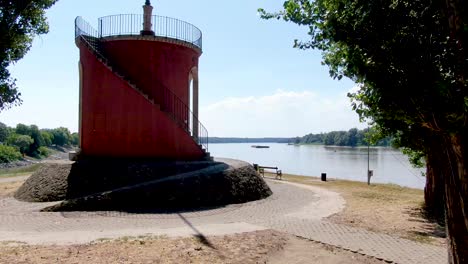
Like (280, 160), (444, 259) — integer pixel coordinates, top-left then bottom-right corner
(0, 0), (57, 111)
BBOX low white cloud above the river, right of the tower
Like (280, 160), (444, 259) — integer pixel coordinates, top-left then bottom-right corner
(200, 90), (366, 137)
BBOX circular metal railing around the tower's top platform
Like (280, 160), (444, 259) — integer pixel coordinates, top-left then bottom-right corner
(98, 14), (202, 50)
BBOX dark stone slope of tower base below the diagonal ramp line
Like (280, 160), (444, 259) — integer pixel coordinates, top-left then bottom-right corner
(43, 160), (272, 212)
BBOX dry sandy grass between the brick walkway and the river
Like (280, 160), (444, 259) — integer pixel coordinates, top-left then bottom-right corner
(278, 175), (446, 246)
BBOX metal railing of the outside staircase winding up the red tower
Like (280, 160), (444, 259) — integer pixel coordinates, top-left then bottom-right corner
(75, 17), (208, 151)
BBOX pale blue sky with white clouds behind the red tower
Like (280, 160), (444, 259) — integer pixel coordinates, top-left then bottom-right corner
(0, 0), (365, 137)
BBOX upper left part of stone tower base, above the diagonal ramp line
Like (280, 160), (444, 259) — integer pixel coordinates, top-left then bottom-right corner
(15, 158), (221, 202)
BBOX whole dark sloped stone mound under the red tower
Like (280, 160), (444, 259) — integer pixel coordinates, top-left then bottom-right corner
(15, 159), (272, 212)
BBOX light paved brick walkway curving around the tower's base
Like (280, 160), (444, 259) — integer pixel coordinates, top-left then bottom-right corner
(0, 178), (447, 264)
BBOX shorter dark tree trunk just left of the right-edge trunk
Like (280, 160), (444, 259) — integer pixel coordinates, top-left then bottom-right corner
(424, 150), (449, 220)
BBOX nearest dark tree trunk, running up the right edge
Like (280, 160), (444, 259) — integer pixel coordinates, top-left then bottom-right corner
(443, 0), (468, 264)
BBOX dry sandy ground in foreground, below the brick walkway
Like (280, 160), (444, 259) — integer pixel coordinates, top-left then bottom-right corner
(0, 230), (383, 264)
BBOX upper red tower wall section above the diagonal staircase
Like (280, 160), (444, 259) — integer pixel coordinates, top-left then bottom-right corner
(103, 38), (200, 105)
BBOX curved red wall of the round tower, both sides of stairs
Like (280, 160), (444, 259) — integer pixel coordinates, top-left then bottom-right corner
(80, 41), (204, 160)
